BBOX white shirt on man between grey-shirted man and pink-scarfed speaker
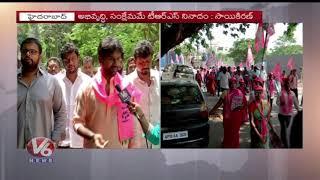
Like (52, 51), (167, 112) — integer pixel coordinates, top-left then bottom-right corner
(55, 69), (91, 148)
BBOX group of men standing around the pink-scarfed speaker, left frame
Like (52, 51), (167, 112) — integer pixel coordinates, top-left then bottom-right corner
(17, 37), (160, 149)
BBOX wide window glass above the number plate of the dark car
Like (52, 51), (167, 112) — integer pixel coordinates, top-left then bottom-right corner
(161, 85), (202, 105)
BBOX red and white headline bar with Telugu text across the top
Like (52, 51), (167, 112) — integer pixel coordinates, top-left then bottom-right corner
(17, 11), (262, 23)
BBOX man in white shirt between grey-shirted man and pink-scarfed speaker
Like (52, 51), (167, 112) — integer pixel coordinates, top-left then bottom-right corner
(55, 43), (91, 148)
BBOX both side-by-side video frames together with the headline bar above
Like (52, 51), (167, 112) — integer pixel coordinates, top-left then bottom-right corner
(17, 11), (303, 151)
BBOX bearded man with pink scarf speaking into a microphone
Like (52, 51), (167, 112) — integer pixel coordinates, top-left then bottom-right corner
(73, 37), (142, 149)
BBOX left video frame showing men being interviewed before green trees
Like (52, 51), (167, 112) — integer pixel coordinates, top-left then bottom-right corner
(17, 23), (160, 150)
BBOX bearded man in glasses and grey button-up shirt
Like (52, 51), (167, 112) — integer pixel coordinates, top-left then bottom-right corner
(17, 38), (67, 148)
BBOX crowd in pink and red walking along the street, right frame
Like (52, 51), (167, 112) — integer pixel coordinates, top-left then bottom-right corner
(195, 65), (302, 148)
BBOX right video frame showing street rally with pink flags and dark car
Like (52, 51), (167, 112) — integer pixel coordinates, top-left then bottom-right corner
(160, 23), (303, 149)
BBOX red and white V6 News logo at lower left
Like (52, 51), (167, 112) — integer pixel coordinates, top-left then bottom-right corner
(27, 137), (55, 163)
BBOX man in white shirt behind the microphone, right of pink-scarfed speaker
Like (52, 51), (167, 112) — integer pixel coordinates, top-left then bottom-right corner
(125, 40), (161, 148)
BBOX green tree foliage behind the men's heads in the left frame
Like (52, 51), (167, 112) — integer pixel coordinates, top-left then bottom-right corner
(18, 23), (160, 66)
